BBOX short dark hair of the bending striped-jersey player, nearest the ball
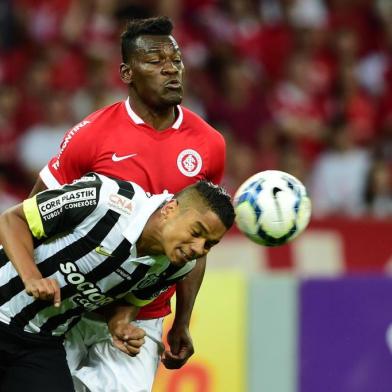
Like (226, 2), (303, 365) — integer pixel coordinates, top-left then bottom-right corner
(175, 180), (235, 230)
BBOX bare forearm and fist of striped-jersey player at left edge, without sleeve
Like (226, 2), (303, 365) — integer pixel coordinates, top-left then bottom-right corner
(0, 204), (61, 306)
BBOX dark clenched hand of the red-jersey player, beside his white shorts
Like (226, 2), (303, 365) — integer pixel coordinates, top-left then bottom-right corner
(162, 326), (195, 369)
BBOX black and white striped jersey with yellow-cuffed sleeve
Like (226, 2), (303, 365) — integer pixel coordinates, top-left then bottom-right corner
(0, 173), (195, 336)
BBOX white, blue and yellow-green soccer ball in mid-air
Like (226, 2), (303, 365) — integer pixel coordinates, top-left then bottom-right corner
(234, 170), (311, 246)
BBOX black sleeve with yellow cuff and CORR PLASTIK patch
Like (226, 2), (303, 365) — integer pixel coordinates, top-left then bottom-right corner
(23, 174), (102, 239)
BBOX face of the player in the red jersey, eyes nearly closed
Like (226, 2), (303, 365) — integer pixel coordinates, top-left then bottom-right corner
(126, 35), (184, 108)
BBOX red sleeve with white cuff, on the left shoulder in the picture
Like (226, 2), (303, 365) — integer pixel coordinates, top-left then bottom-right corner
(40, 119), (97, 189)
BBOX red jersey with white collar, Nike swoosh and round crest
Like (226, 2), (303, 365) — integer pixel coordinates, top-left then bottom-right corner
(40, 100), (225, 319)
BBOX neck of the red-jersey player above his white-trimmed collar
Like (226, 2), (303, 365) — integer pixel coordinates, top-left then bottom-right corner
(129, 91), (177, 131)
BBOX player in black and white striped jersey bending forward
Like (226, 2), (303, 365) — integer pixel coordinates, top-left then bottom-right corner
(0, 173), (234, 392)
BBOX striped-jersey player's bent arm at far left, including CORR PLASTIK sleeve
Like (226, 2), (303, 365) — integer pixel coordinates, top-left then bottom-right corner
(0, 175), (102, 306)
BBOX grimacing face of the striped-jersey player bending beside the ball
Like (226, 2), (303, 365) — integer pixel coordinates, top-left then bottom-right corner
(162, 202), (227, 266)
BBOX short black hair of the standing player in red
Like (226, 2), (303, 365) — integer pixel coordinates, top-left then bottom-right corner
(121, 16), (173, 63)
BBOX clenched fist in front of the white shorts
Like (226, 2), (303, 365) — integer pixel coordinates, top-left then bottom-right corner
(108, 322), (146, 357)
